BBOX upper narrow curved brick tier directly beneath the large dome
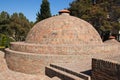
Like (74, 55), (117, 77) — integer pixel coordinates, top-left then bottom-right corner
(10, 42), (118, 55)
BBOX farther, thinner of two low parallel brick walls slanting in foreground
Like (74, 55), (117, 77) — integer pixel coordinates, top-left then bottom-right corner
(50, 64), (91, 80)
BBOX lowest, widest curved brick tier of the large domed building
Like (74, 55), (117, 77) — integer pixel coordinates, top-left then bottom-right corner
(5, 49), (88, 74)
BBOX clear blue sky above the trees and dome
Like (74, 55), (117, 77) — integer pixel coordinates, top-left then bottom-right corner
(0, 0), (73, 21)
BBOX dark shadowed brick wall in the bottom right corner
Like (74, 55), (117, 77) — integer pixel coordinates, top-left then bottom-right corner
(92, 59), (120, 80)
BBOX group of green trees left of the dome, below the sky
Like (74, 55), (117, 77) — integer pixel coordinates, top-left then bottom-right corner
(0, 11), (33, 43)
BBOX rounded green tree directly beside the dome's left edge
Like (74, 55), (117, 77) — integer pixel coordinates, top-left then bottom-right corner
(10, 13), (31, 41)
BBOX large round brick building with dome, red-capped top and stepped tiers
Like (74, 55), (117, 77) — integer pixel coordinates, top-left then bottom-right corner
(5, 10), (113, 74)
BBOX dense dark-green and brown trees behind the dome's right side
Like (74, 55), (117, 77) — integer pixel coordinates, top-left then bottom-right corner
(69, 0), (120, 32)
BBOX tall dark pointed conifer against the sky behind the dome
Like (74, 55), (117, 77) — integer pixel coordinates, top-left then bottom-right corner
(36, 0), (51, 22)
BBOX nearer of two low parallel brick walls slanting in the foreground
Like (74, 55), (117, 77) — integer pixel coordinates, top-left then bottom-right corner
(45, 66), (85, 80)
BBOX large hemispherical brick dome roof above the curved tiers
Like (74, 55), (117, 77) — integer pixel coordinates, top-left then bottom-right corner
(26, 10), (102, 44)
